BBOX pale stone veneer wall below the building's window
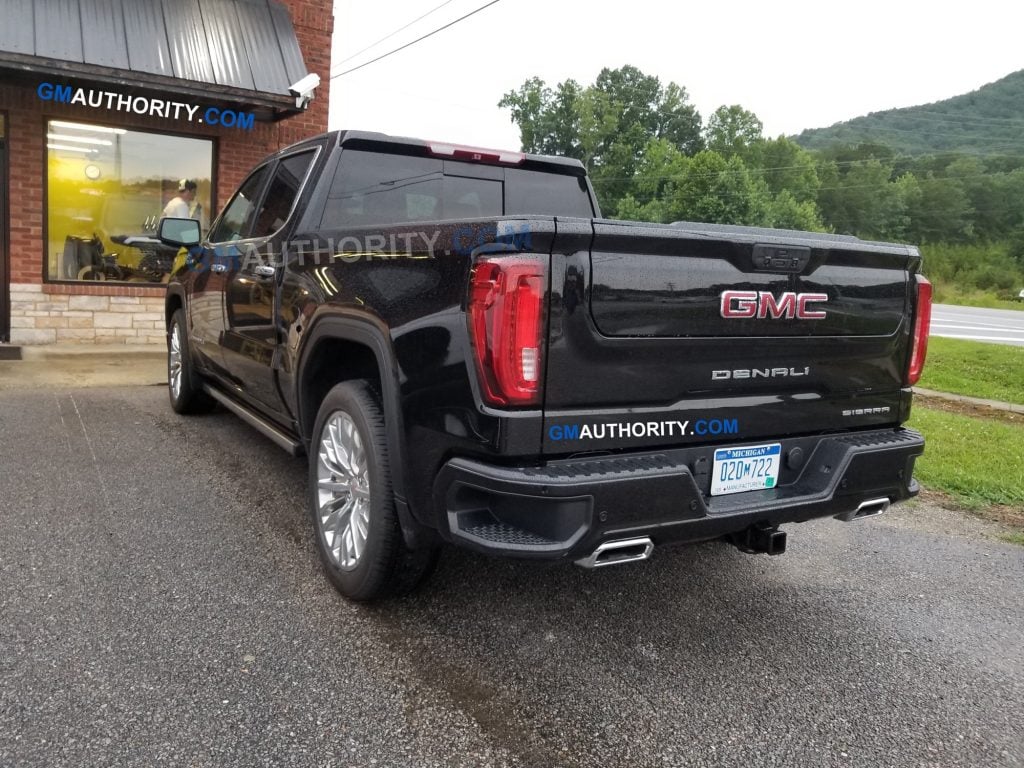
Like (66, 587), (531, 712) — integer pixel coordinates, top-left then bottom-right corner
(10, 284), (167, 344)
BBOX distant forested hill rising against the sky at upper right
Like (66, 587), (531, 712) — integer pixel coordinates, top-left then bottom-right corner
(796, 70), (1024, 155)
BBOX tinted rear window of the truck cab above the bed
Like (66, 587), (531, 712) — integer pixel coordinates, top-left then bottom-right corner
(321, 150), (593, 228)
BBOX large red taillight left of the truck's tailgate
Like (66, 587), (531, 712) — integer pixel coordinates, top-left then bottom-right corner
(468, 256), (547, 406)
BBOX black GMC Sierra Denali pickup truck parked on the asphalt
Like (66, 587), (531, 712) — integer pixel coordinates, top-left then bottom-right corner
(160, 131), (931, 600)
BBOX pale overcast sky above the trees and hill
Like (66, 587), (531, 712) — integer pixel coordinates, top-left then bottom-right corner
(330, 0), (1024, 148)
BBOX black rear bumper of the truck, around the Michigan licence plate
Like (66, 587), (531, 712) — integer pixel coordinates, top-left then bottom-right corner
(434, 429), (925, 560)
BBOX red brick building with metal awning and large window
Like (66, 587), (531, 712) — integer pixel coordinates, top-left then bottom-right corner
(0, 0), (334, 344)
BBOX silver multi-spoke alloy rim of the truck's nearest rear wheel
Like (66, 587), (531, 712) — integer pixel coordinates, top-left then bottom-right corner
(316, 412), (370, 570)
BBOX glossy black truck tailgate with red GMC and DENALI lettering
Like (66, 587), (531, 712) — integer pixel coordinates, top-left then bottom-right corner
(544, 220), (920, 453)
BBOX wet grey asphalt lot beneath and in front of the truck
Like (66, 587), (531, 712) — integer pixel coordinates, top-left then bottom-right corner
(0, 387), (1024, 768)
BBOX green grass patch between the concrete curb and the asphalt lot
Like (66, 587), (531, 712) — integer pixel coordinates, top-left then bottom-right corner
(909, 408), (1024, 511)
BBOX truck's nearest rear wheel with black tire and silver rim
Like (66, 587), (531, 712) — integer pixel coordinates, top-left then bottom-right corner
(307, 380), (437, 601)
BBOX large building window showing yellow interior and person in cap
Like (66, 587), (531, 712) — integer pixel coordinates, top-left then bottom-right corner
(46, 120), (213, 283)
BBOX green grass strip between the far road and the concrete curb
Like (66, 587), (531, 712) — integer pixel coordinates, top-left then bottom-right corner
(920, 336), (1024, 405)
